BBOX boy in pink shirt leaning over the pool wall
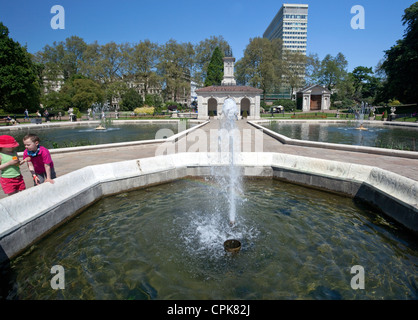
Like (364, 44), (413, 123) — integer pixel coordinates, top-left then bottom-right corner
(23, 134), (57, 186)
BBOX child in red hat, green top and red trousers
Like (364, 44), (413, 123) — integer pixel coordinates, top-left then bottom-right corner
(0, 135), (26, 196)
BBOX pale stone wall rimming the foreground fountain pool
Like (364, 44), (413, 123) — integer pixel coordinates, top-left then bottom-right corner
(0, 152), (418, 263)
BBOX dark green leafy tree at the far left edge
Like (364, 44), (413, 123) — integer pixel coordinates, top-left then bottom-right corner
(0, 22), (40, 113)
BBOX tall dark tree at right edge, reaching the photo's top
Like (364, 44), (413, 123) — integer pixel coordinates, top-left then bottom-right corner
(381, 2), (418, 103)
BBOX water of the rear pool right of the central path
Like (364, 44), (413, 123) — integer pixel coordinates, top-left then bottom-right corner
(266, 122), (418, 151)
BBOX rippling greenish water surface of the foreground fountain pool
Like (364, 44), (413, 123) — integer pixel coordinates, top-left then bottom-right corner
(3, 179), (418, 299)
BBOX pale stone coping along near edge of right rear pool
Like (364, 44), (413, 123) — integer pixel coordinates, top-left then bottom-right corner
(248, 121), (418, 159)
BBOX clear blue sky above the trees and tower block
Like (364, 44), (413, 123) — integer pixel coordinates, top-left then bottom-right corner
(0, 0), (415, 71)
